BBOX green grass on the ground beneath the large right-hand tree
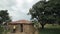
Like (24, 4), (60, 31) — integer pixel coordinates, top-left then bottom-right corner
(39, 24), (60, 34)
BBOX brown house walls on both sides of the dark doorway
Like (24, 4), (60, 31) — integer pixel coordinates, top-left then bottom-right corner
(9, 24), (38, 34)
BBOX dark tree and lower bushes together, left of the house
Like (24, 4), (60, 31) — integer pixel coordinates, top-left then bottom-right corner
(0, 10), (11, 34)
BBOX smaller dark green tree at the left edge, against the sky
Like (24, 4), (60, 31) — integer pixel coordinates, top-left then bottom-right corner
(0, 10), (11, 24)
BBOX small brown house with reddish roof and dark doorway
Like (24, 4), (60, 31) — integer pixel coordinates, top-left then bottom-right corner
(8, 20), (38, 34)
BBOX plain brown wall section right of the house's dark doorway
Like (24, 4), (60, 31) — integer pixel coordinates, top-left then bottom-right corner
(23, 24), (35, 34)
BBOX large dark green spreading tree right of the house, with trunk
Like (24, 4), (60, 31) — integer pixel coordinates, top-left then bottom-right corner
(29, 0), (60, 29)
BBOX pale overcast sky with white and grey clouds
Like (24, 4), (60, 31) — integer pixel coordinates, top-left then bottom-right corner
(0, 0), (39, 21)
